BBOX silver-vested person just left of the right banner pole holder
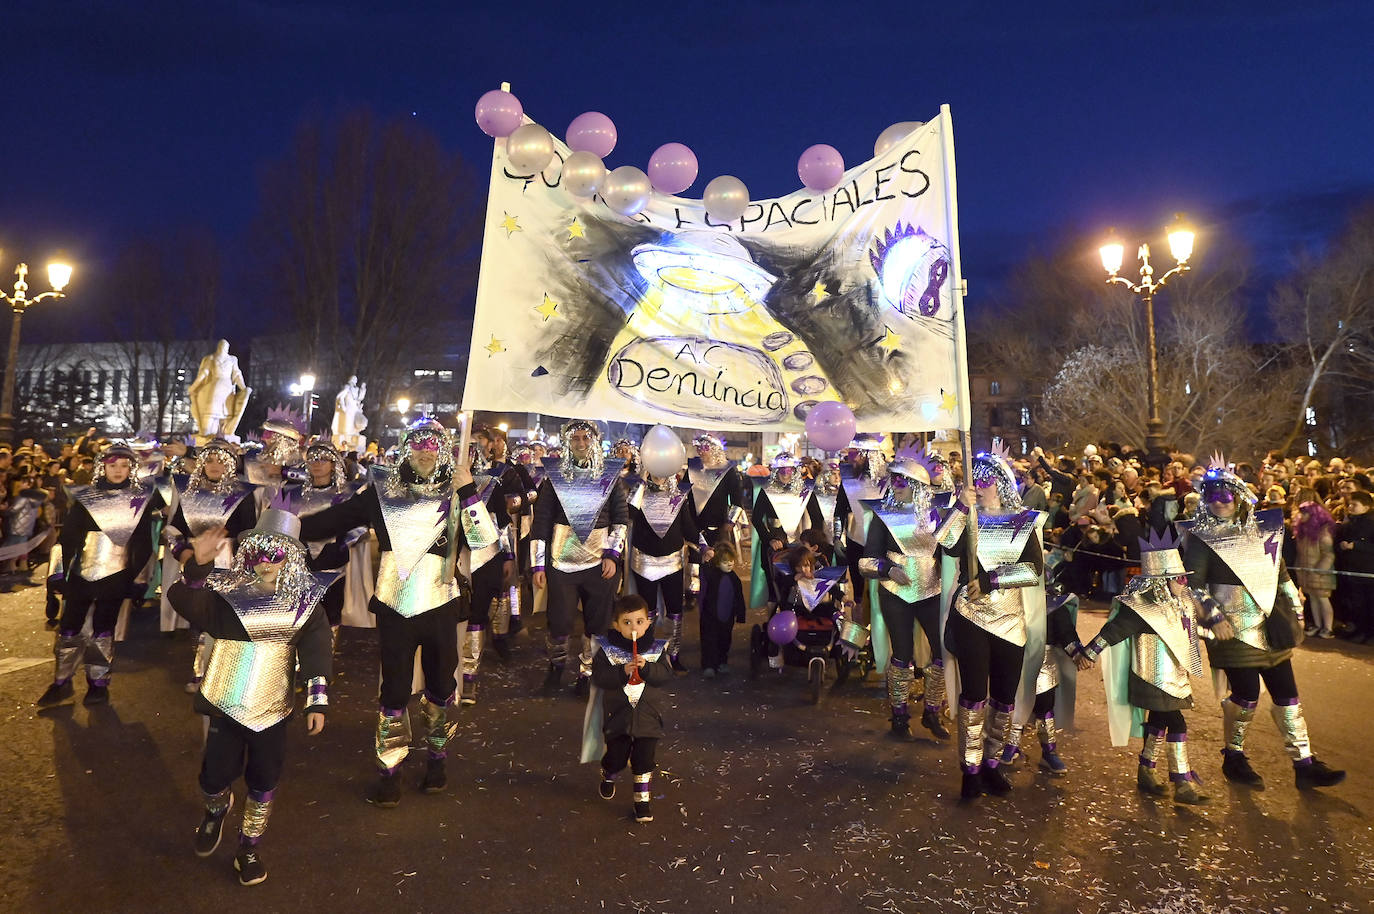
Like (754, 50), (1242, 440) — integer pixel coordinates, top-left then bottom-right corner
(859, 449), (949, 739)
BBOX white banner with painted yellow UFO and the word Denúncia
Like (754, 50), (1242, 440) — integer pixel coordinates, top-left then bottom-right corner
(463, 115), (958, 432)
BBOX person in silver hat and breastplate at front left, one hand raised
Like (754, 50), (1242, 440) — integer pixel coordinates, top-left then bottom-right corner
(169, 499), (333, 885)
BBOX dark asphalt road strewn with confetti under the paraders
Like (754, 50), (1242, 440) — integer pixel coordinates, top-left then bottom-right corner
(0, 577), (1374, 914)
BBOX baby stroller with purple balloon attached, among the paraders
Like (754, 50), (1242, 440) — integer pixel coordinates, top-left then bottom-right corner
(749, 564), (853, 705)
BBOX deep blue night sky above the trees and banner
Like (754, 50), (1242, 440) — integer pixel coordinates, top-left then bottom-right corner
(0, 0), (1374, 335)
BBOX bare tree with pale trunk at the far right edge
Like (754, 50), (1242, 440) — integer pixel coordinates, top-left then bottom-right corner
(1270, 205), (1374, 451)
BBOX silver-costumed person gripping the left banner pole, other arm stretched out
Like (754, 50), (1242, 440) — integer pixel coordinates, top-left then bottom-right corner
(301, 416), (497, 807)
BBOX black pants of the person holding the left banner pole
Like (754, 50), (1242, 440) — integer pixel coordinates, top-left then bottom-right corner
(372, 597), (460, 711)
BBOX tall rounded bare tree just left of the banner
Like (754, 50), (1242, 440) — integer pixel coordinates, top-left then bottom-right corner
(254, 113), (482, 427)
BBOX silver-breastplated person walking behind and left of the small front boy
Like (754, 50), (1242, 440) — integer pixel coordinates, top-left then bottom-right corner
(529, 419), (629, 697)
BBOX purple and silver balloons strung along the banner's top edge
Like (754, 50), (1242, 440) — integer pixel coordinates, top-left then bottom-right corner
(477, 89), (921, 223)
